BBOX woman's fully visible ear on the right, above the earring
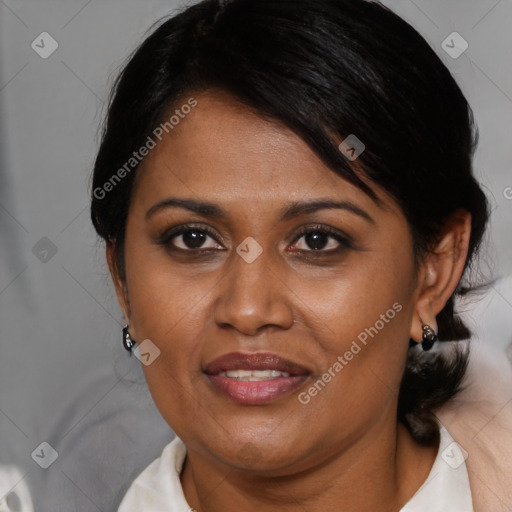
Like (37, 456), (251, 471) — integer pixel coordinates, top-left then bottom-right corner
(410, 210), (471, 341)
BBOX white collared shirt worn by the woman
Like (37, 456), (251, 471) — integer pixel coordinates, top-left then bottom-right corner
(118, 424), (473, 512)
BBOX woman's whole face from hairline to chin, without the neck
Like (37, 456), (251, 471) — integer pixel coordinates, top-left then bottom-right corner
(111, 93), (424, 474)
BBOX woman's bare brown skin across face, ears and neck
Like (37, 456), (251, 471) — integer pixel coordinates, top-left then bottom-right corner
(107, 91), (470, 512)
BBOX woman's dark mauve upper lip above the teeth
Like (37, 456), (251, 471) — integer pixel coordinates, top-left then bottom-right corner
(204, 352), (309, 375)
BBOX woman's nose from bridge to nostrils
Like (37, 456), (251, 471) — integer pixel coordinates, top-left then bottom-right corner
(214, 247), (293, 336)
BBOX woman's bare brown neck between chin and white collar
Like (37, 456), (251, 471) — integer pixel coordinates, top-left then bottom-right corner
(181, 422), (438, 512)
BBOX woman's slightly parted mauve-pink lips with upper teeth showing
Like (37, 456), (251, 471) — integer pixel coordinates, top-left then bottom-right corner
(203, 352), (309, 405)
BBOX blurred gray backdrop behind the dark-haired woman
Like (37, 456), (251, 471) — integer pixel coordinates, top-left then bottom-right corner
(0, 0), (512, 511)
